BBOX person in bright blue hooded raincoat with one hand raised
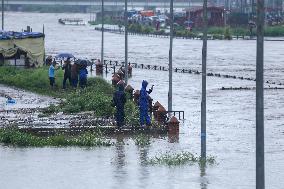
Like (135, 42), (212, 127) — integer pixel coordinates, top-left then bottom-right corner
(139, 80), (153, 126)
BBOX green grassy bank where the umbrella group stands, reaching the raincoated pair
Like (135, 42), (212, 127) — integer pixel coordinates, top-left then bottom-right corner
(0, 67), (139, 125)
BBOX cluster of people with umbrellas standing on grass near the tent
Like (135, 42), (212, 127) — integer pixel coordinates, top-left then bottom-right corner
(48, 58), (88, 89)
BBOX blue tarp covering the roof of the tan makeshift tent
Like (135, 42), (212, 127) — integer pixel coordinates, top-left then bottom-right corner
(0, 31), (44, 40)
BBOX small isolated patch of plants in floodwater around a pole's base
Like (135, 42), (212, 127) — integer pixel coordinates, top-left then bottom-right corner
(148, 152), (216, 166)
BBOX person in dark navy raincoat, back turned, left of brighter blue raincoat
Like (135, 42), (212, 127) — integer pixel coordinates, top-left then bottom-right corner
(113, 84), (126, 128)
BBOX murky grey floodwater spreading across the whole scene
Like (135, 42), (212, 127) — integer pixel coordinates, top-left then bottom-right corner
(0, 12), (284, 189)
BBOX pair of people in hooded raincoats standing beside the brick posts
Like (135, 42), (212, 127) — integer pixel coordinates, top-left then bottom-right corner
(113, 80), (153, 128)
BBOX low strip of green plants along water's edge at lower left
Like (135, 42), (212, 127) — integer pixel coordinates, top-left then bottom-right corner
(0, 128), (112, 147)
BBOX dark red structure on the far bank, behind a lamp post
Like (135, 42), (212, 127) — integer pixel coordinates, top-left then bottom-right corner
(186, 7), (224, 28)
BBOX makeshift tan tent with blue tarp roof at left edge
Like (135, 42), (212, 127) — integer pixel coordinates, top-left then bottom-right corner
(0, 31), (44, 67)
